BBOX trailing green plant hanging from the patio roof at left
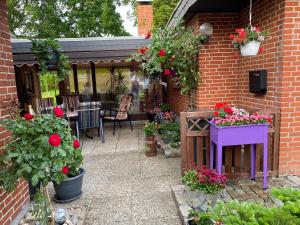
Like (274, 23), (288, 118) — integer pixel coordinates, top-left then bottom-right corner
(31, 39), (70, 80)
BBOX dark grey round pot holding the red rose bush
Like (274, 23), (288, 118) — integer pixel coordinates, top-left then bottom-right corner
(53, 168), (85, 203)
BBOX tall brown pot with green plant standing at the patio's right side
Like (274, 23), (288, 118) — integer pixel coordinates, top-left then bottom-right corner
(144, 122), (157, 157)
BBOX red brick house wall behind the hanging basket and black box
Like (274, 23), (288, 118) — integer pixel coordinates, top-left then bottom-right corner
(168, 0), (300, 175)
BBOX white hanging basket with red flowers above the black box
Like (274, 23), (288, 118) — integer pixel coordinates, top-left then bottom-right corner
(229, 25), (268, 56)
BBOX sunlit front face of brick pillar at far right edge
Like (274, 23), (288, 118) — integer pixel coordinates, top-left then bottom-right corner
(279, 0), (300, 175)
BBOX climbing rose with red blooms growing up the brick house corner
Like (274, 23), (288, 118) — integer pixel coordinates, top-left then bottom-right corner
(130, 23), (203, 108)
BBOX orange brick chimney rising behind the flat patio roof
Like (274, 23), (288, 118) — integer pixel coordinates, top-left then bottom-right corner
(137, 2), (153, 36)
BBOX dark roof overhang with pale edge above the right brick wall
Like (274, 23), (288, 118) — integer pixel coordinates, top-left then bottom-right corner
(167, 0), (255, 26)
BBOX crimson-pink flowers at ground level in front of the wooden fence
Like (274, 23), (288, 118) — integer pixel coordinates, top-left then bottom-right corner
(182, 166), (227, 211)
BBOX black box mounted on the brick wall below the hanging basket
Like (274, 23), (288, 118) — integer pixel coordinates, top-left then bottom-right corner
(249, 70), (267, 94)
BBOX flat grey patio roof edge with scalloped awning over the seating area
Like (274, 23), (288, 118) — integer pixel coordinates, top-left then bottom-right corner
(11, 36), (150, 66)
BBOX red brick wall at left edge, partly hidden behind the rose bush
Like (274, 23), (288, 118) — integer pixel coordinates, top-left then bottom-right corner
(0, 0), (28, 225)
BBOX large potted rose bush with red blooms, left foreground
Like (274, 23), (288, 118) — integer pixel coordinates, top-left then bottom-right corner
(0, 107), (85, 225)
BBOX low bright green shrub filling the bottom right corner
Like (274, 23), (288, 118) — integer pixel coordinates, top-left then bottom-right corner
(189, 188), (300, 225)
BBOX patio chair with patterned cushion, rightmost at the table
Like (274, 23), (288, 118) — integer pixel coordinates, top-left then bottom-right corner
(104, 94), (133, 135)
